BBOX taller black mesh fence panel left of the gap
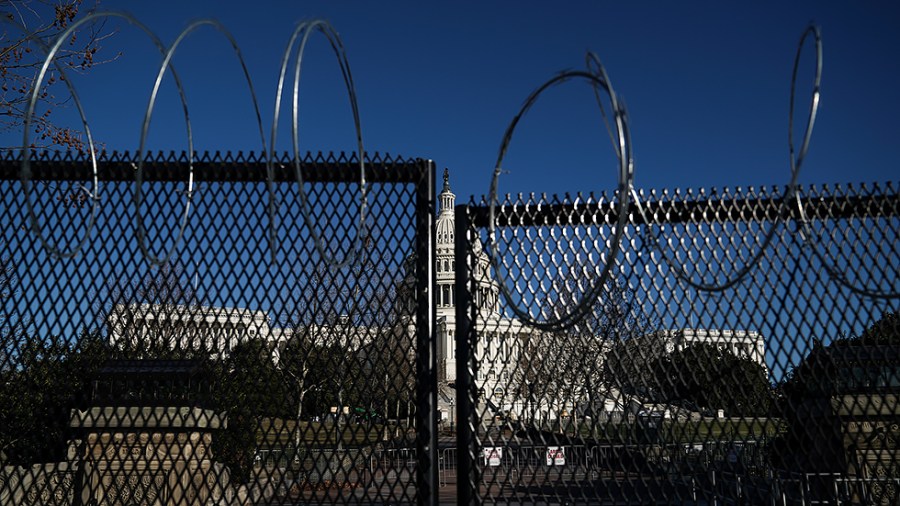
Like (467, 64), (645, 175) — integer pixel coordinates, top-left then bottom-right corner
(0, 153), (438, 506)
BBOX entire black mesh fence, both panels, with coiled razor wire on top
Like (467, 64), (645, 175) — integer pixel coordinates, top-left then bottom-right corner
(0, 13), (900, 506)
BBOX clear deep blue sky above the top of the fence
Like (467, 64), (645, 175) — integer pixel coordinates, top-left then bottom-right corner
(21, 0), (900, 202)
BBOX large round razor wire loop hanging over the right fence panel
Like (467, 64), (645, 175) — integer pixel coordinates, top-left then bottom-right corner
(487, 59), (634, 330)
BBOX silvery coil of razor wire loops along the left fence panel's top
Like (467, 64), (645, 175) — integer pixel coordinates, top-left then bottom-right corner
(16, 12), (368, 269)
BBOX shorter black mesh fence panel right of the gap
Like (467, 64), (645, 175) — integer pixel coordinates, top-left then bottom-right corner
(458, 183), (900, 504)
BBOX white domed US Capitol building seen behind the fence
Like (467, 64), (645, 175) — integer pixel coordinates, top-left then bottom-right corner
(107, 169), (765, 421)
